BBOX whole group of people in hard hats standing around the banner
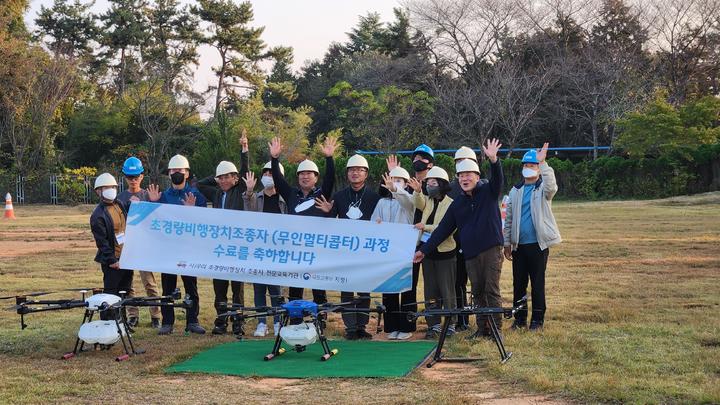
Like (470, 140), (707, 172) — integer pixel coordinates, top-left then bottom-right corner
(90, 130), (561, 340)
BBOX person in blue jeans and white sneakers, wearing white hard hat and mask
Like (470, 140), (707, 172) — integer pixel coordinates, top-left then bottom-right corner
(243, 162), (287, 337)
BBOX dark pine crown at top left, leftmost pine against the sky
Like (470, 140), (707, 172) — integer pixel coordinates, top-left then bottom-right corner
(35, 0), (98, 63)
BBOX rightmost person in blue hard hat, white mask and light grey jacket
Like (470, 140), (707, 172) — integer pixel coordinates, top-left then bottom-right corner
(503, 143), (562, 330)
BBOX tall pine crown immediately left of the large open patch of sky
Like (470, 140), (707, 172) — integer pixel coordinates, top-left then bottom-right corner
(193, 0), (270, 114)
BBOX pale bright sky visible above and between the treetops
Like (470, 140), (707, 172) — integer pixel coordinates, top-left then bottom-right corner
(25, 0), (399, 107)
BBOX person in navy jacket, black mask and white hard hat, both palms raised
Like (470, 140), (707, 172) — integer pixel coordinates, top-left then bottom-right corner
(148, 155), (207, 335)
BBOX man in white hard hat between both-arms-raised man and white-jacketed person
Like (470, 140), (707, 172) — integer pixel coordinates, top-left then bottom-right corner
(318, 155), (380, 340)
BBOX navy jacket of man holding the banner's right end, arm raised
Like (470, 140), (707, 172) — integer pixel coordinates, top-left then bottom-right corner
(420, 159), (503, 259)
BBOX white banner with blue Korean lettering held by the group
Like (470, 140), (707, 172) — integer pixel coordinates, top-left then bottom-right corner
(120, 202), (418, 293)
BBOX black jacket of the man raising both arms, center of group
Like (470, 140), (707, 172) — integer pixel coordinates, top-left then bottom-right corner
(271, 157), (335, 217)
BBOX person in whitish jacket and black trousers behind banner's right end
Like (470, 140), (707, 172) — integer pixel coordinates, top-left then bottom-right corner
(370, 163), (417, 340)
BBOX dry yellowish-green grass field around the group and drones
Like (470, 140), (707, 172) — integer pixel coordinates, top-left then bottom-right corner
(0, 193), (720, 404)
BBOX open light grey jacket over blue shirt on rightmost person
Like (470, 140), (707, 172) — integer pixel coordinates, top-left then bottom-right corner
(503, 162), (562, 250)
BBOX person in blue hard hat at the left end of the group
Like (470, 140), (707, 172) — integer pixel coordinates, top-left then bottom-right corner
(117, 156), (161, 329)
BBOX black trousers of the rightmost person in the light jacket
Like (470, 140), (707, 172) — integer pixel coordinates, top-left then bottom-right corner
(512, 243), (550, 324)
